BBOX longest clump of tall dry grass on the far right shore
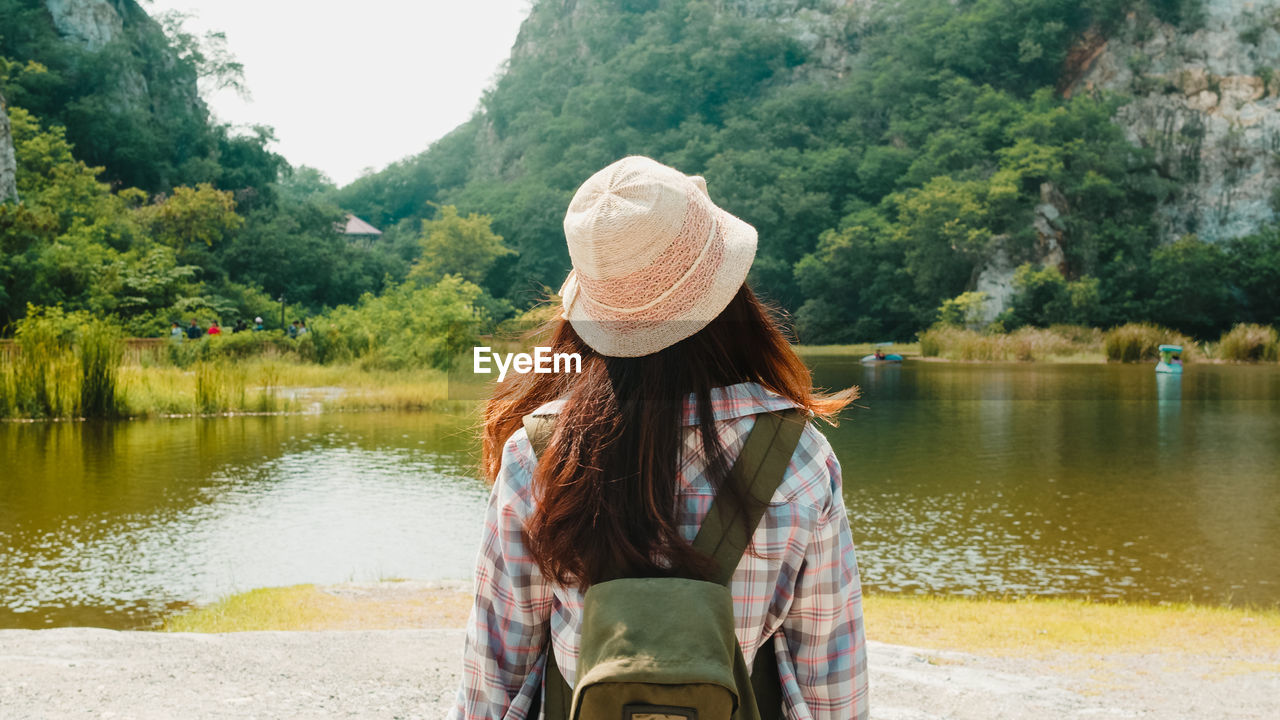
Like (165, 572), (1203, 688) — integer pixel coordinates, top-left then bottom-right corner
(920, 324), (1102, 363)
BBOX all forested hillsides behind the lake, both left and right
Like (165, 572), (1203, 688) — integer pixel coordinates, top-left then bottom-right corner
(0, 0), (1280, 342)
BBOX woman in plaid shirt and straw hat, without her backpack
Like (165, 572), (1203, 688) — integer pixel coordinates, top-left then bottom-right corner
(451, 158), (868, 720)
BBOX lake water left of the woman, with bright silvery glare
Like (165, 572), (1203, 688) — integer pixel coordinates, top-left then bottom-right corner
(0, 414), (486, 626)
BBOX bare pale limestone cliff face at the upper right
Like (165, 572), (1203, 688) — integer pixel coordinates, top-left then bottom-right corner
(1068, 0), (1280, 241)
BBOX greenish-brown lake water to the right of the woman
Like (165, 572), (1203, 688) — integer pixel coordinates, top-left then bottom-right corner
(818, 359), (1280, 603)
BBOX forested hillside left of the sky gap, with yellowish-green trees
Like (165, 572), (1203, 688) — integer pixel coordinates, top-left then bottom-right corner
(0, 0), (412, 334)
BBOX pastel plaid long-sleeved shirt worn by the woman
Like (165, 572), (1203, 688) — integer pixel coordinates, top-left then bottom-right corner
(449, 383), (868, 720)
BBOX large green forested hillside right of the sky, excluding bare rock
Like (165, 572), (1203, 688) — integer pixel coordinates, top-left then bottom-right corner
(338, 0), (1280, 342)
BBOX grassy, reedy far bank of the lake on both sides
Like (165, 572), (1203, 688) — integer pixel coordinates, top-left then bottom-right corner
(10, 324), (1280, 420)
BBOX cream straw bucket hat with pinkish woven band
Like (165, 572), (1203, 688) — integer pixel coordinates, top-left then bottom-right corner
(559, 156), (756, 357)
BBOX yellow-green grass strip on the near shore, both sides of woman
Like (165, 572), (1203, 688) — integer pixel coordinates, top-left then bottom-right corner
(163, 582), (1280, 656)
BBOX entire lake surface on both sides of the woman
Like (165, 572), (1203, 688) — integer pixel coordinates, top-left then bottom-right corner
(0, 357), (1280, 628)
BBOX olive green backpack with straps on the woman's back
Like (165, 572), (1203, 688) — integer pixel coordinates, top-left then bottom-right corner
(524, 410), (805, 720)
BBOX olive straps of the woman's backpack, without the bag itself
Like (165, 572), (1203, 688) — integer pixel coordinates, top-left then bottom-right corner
(524, 409), (806, 720)
